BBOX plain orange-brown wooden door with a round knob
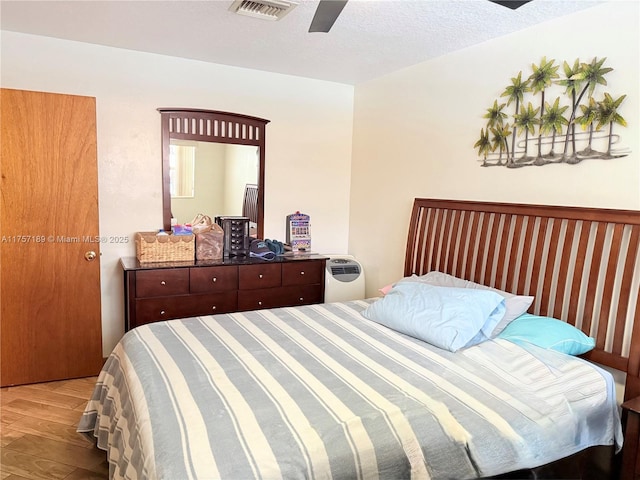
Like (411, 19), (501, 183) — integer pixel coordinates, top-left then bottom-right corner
(0, 89), (102, 386)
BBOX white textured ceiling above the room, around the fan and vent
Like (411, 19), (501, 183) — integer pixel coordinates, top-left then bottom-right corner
(0, 0), (603, 84)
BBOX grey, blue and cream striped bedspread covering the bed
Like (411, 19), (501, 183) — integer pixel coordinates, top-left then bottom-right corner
(78, 301), (622, 480)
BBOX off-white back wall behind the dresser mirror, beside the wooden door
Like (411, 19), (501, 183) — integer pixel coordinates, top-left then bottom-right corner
(0, 31), (353, 355)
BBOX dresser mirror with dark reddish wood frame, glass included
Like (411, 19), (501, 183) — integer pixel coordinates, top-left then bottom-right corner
(158, 108), (269, 238)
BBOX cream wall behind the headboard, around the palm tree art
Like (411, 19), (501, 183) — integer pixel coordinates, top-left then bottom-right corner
(349, 1), (640, 296)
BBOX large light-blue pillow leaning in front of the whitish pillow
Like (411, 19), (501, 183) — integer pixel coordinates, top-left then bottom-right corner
(362, 282), (505, 352)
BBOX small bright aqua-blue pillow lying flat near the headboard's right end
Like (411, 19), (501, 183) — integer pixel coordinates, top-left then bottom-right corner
(498, 313), (596, 355)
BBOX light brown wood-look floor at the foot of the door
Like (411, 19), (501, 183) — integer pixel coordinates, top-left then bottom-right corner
(0, 377), (109, 480)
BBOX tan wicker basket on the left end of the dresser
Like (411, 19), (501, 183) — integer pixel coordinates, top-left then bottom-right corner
(136, 232), (196, 263)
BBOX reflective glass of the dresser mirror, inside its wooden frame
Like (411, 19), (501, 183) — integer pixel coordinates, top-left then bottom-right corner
(170, 139), (259, 229)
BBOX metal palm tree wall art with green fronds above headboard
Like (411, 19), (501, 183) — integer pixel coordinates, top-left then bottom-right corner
(474, 57), (630, 168)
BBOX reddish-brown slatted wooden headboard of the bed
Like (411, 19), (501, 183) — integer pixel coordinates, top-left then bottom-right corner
(404, 198), (640, 400)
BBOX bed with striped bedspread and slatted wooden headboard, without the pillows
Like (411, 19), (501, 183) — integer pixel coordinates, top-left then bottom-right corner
(78, 199), (640, 479)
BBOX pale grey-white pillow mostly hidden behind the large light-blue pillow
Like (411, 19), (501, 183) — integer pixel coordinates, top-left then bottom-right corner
(400, 272), (533, 338)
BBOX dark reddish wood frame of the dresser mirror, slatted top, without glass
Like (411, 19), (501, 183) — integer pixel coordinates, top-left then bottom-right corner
(158, 108), (269, 238)
